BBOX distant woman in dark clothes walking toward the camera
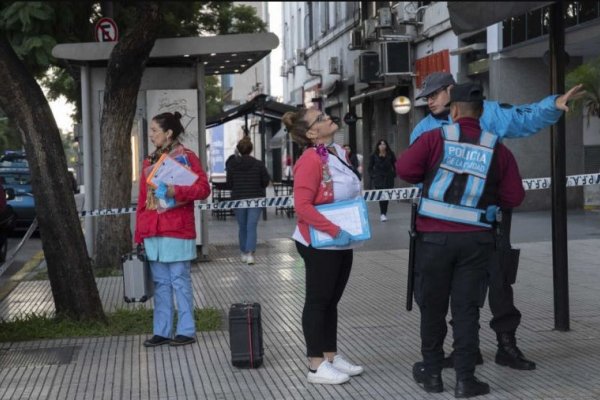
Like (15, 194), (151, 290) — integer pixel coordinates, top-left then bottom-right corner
(369, 139), (396, 222)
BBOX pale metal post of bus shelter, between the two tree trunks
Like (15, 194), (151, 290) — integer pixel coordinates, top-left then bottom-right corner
(81, 65), (96, 257)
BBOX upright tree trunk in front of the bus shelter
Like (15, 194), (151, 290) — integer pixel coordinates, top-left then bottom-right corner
(95, 3), (160, 268)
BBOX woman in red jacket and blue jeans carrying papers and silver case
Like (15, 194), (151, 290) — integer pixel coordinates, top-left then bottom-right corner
(134, 112), (210, 347)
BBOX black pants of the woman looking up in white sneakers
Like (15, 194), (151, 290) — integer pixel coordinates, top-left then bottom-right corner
(296, 242), (353, 357)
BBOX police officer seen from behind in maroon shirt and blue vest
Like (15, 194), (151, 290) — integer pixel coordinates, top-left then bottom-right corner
(396, 83), (525, 398)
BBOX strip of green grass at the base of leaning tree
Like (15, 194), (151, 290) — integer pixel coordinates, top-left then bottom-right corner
(0, 307), (222, 343)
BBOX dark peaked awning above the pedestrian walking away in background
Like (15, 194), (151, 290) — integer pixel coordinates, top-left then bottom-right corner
(206, 94), (297, 129)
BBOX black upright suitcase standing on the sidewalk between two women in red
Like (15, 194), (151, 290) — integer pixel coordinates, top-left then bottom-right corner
(229, 303), (264, 368)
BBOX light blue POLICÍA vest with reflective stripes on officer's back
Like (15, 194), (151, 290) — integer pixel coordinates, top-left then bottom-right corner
(419, 124), (498, 227)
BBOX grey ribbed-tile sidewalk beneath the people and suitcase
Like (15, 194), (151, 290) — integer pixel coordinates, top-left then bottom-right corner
(0, 206), (600, 400)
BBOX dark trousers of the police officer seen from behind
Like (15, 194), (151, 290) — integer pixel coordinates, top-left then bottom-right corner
(415, 232), (494, 380)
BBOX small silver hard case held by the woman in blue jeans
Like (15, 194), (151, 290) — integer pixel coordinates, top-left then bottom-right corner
(122, 253), (154, 303)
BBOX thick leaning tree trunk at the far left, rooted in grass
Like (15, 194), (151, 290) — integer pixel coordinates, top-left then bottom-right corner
(0, 33), (105, 321)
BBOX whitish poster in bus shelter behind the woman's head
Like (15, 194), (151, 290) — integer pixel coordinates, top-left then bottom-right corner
(146, 89), (198, 158)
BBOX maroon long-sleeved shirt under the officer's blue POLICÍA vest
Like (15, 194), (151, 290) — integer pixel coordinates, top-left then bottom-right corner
(396, 118), (525, 232)
